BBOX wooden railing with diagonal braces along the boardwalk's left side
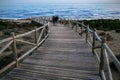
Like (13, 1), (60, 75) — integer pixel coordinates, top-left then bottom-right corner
(0, 20), (49, 75)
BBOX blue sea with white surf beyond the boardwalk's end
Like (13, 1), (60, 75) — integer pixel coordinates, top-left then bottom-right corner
(0, 3), (120, 19)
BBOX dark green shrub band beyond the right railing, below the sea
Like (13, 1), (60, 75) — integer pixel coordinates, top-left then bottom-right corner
(79, 19), (120, 31)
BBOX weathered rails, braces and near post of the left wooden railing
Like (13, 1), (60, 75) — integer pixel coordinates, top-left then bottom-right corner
(0, 21), (48, 74)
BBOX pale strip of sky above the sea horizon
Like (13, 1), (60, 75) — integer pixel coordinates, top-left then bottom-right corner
(0, 0), (120, 3)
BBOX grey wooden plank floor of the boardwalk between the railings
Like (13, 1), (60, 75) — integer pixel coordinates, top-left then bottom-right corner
(0, 24), (100, 80)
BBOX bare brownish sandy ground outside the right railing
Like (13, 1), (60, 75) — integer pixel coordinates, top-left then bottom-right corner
(97, 30), (120, 80)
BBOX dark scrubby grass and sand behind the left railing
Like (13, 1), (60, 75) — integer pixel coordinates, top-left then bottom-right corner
(0, 19), (41, 68)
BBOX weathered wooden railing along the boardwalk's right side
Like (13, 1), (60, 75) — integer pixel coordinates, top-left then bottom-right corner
(61, 19), (120, 80)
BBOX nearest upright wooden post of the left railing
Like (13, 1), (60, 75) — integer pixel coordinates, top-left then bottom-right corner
(12, 32), (18, 67)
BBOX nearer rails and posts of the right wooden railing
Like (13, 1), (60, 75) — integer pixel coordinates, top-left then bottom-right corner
(77, 21), (120, 80)
